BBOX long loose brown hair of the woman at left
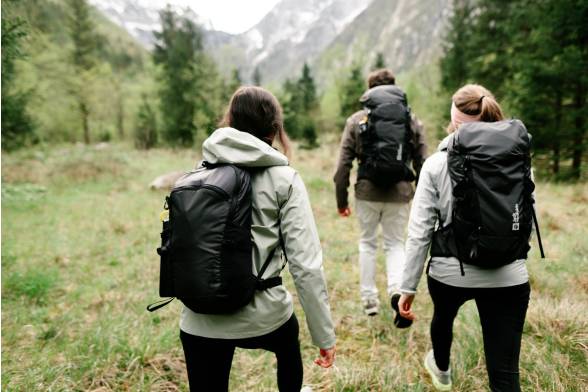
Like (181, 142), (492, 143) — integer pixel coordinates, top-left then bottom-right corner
(221, 86), (292, 157)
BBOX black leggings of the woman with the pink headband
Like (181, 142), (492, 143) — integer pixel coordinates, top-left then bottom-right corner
(427, 277), (531, 392)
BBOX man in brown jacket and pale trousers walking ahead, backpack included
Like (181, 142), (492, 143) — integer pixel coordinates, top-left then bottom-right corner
(334, 69), (426, 322)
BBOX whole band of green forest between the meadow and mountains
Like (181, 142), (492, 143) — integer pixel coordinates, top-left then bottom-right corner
(2, 0), (588, 180)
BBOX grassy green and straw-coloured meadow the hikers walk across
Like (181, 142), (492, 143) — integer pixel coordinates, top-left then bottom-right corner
(2, 139), (588, 391)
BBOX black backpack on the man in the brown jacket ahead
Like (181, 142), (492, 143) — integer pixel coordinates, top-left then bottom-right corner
(358, 85), (415, 188)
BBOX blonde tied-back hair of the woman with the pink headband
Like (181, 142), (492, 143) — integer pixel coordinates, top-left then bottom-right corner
(447, 84), (504, 133)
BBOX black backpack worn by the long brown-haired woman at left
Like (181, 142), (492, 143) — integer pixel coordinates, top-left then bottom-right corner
(147, 162), (285, 314)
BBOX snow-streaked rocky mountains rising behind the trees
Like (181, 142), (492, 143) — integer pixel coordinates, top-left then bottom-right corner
(91, 0), (451, 85)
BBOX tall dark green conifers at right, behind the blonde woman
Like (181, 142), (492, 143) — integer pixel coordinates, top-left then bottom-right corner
(441, 0), (588, 179)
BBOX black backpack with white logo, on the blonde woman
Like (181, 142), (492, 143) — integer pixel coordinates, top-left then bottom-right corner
(431, 120), (544, 275)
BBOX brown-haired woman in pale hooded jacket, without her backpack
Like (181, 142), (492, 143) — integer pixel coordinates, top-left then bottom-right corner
(180, 86), (335, 392)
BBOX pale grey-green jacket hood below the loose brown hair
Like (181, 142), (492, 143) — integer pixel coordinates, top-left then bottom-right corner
(202, 128), (288, 167)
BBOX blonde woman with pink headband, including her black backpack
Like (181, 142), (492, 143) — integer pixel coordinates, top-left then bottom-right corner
(399, 84), (542, 391)
